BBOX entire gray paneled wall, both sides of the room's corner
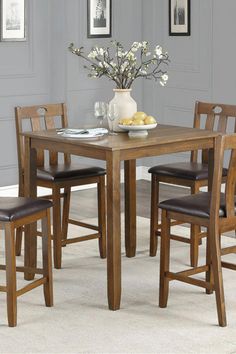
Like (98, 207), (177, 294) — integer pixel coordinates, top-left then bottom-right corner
(0, 0), (236, 186)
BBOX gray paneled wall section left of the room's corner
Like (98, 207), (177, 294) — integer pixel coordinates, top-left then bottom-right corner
(0, 0), (142, 186)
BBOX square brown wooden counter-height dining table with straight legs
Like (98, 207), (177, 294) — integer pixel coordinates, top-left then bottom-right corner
(22, 124), (219, 310)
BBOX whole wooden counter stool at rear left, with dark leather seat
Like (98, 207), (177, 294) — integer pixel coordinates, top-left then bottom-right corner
(15, 103), (106, 269)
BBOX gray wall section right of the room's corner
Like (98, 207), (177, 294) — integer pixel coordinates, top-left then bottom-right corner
(143, 0), (236, 166)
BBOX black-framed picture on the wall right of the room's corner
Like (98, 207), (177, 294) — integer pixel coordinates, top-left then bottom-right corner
(169, 0), (190, 36)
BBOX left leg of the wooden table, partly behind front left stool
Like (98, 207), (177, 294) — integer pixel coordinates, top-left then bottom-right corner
(24, 138), (37, 280)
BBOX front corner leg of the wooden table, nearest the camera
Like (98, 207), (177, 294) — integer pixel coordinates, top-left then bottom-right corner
(107, 152), (121, 310)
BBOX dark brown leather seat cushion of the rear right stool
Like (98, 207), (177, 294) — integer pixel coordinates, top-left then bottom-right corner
(148, 162), (227, 181)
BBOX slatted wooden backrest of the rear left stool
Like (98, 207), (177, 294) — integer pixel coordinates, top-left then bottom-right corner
(15, 103), (70, 175)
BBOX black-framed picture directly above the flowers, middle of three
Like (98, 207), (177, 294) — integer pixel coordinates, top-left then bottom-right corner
(87, 0), (112, 38)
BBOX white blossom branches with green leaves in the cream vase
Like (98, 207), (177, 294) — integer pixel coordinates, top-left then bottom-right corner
(68, 41), (170, 89)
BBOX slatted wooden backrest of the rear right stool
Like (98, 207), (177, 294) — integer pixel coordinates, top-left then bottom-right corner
(191, 101), (236, 163)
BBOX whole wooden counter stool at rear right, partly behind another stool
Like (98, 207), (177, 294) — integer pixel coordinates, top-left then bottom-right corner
(149, 102), (236, 266)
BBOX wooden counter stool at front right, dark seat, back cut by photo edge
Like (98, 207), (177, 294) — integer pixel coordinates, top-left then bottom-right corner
(159, 134), (236, 326)
